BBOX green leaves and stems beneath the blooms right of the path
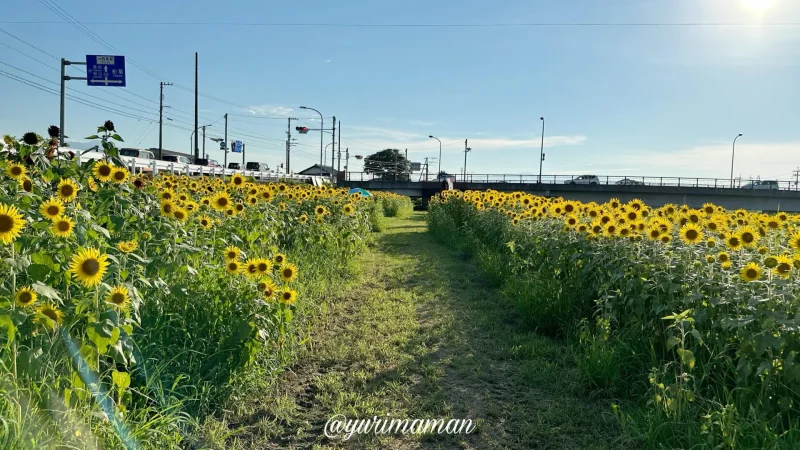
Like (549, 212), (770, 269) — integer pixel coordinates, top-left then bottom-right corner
(428, 194), (800, 449)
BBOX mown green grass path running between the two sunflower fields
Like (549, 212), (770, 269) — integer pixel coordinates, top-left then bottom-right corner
(226, 213), (620, 449)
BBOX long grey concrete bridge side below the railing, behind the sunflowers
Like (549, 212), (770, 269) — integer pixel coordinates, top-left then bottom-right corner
(338, 180), (800, 212)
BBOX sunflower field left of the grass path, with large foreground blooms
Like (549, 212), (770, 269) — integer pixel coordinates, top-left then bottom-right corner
(0, 122), (382, 449)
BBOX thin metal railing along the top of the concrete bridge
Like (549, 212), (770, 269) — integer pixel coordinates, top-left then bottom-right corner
(346, 172), (800, 191)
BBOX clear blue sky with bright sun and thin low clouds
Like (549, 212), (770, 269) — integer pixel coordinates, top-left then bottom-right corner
(0, 0), (800, 179)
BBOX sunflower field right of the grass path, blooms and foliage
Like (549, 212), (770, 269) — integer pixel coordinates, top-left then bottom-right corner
(428, 191), (800, 449)
